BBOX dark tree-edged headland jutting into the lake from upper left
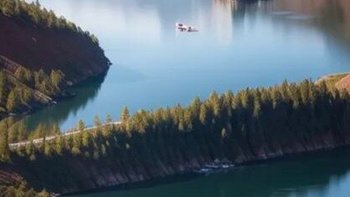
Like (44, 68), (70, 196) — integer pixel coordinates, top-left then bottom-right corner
(0, 0), (110, 117)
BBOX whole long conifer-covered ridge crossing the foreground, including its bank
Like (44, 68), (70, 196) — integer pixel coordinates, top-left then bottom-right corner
(0, 80), (350, 193)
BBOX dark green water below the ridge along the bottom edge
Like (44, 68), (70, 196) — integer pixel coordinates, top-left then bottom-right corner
(68, 148), (350, 197)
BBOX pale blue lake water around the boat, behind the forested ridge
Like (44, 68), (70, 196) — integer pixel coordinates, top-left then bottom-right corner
(26, 0), (350, 134)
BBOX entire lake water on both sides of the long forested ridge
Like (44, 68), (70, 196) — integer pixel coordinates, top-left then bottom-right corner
(25, 0), (350, 196)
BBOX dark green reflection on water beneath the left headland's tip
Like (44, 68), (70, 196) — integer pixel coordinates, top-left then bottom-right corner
(23, 70), (106, 132)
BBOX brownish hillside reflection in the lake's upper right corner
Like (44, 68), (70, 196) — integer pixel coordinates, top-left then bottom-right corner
(232, 0), (350, 69)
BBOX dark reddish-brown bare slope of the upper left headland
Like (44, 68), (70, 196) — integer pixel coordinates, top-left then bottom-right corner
(0, 13), (109, 84)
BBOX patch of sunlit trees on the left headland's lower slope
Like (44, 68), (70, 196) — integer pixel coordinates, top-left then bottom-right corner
(0, 66), (66, 113)
